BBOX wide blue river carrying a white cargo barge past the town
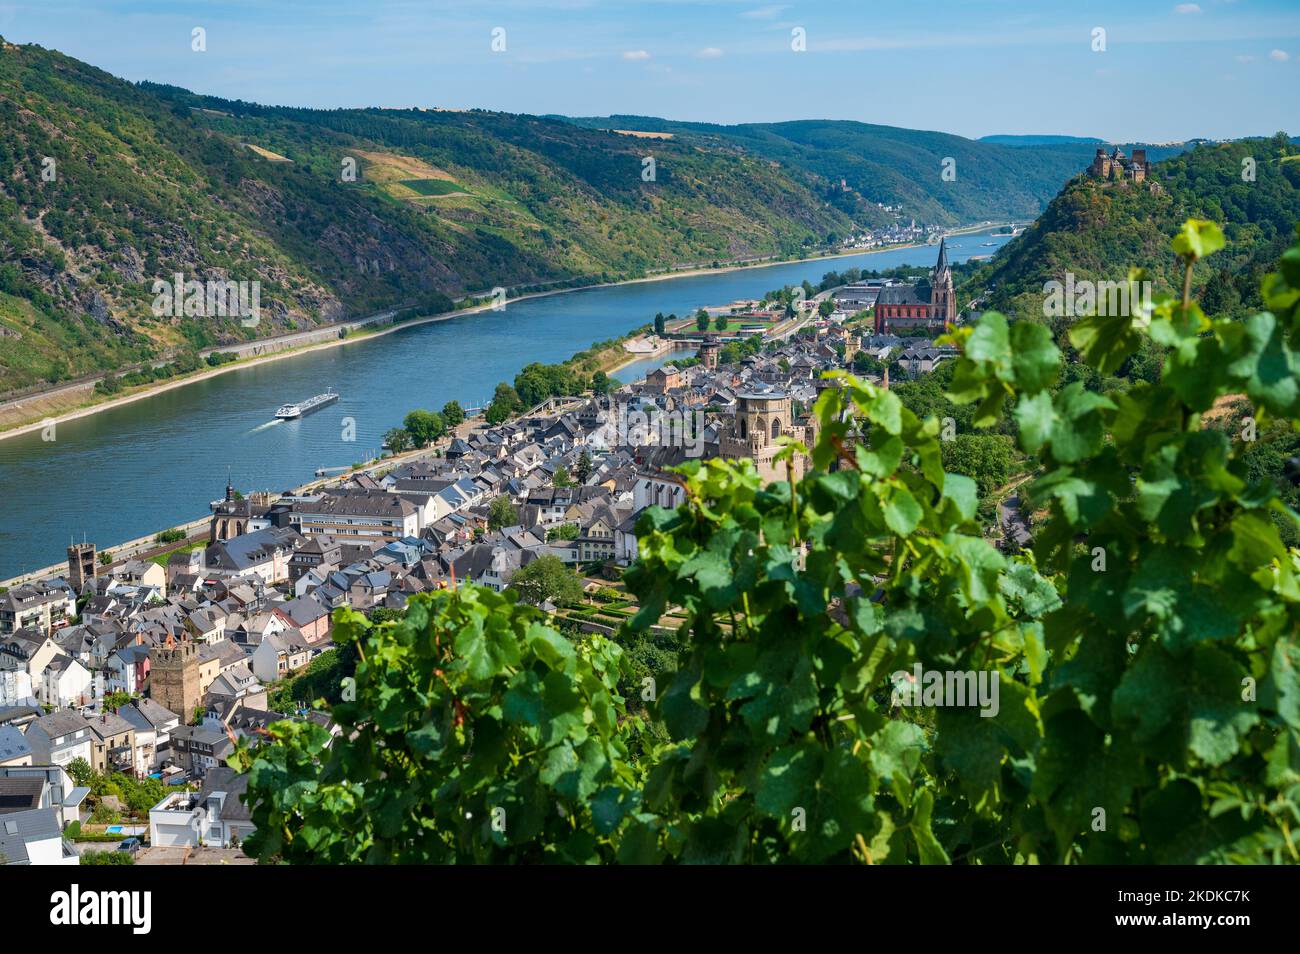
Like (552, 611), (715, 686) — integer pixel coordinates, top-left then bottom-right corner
(0, 233), (1009, 580)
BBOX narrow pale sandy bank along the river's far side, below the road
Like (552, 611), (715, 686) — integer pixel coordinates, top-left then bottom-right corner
(0, 222), (1005, 441)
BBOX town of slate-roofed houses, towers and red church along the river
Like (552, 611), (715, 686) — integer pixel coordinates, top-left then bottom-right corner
(0, 242), (982, 863)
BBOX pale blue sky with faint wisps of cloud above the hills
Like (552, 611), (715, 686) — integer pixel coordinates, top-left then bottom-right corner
(0, 0), (1300, 142)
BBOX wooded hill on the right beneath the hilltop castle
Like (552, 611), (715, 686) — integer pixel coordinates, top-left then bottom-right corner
(961, 134), (1300, 316)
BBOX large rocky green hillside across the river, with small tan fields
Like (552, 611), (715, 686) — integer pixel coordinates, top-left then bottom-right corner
(0, 40), (857, 394)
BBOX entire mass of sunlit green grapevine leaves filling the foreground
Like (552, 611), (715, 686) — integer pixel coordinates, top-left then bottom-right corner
(234, 221), (1300, 864)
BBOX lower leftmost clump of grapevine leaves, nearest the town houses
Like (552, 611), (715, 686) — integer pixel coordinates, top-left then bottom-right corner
(235, 586), (636, 864)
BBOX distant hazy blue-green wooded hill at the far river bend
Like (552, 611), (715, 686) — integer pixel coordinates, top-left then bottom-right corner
(559, 116), (1182, 225)
